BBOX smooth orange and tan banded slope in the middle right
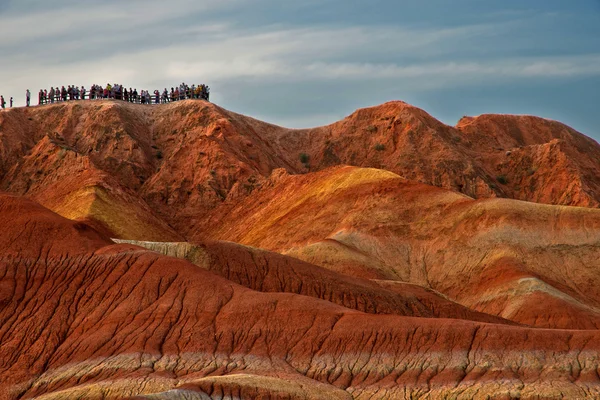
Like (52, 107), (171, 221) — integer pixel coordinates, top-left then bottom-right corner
(196, 167), (600, 329)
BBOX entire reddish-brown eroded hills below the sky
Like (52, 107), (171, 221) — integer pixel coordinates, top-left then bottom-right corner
(0, 101), (600, 400)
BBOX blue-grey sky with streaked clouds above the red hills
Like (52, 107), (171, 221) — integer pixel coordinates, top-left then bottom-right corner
(0, 0), (600, 140)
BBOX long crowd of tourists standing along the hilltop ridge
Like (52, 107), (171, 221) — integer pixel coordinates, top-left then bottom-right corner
(0, 83), (210, 108)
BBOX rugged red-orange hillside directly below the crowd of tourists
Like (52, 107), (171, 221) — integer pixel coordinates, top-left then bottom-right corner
(0, 101), (297, 241)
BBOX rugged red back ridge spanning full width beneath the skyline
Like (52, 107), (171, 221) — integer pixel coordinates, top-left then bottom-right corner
(0, 101), (600, 241)
